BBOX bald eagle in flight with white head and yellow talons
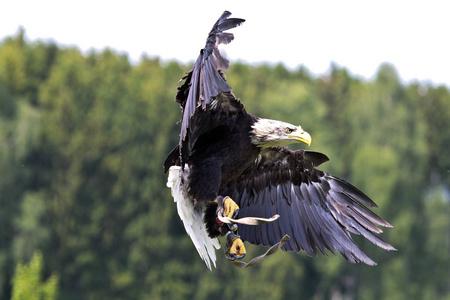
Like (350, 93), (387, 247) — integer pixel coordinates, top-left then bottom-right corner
(164, 11), (395, 269)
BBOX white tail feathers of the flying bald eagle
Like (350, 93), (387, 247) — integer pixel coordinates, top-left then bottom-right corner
(167, 165), (220, 270)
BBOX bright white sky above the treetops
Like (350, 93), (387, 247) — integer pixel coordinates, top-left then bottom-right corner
(0, 0), (450, 85)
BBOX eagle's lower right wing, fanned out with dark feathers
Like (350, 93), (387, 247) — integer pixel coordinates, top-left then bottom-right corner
(235, 147), (395, 265)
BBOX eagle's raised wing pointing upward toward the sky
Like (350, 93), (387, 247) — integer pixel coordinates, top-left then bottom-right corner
(175, 11), (245, 165)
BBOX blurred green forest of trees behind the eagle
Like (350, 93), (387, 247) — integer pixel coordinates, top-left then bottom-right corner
(0, 31), (450, 300)
